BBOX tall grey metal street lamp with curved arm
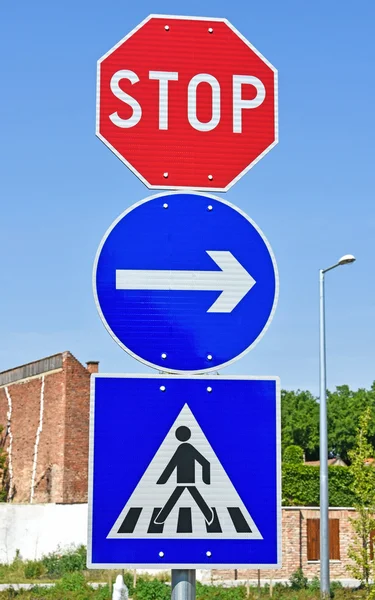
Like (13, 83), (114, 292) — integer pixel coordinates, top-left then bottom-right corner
(319, 254), (355, 598)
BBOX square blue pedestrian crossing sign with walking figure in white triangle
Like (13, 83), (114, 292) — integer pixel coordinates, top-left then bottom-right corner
(88, 374), (280, 568)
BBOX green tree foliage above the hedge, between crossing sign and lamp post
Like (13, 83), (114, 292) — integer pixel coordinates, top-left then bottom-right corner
(281, 390), (319, 460)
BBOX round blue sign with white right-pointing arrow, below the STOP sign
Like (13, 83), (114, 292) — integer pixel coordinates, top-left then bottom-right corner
(93, 192), (278, 373)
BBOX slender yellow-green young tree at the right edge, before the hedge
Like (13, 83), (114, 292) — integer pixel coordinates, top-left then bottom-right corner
(348, 407), (375, 589)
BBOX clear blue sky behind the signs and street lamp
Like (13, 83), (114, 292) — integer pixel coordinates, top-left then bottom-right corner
(0, 0), (375, 393)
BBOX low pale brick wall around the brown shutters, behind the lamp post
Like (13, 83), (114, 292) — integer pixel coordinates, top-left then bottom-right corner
(212, 507), (355, 580)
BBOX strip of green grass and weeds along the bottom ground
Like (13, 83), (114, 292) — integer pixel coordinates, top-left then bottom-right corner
(0, 546), (375, 600)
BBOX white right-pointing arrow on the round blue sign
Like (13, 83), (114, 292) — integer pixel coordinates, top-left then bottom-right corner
(116, 250), (256, 313)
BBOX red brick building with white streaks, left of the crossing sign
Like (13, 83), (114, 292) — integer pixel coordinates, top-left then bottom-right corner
(0, 352), (99, 504)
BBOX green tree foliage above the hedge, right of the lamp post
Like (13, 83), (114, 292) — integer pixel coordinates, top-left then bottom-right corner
(327, 382), (375, 461)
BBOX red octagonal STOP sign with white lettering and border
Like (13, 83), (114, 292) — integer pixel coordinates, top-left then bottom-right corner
(96, 15), (278, 192)
